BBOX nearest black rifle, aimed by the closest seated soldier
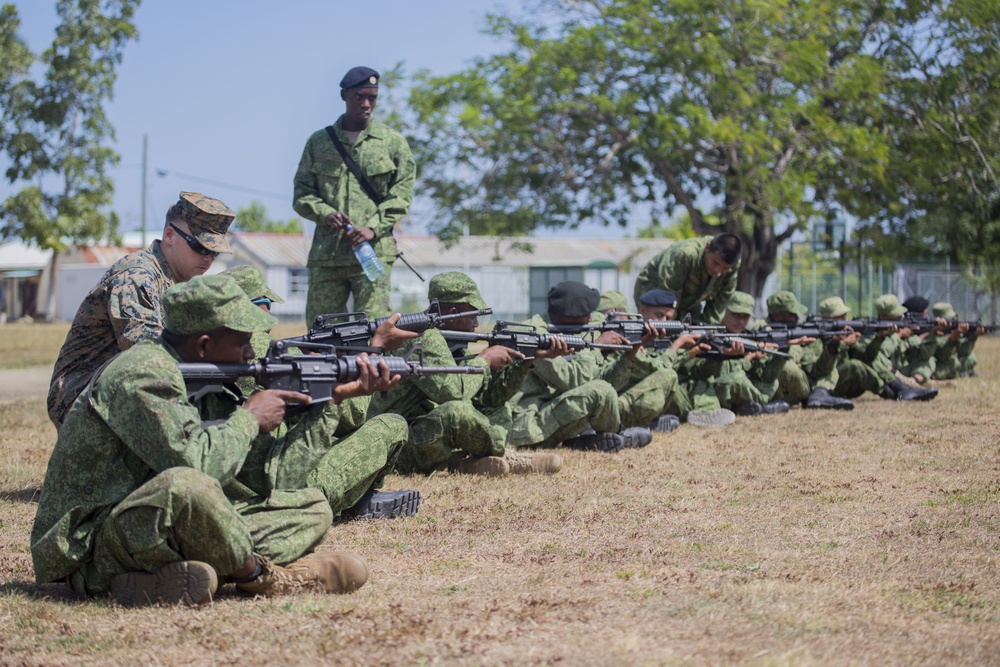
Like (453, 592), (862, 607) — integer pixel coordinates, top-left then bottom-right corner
(178, 340), (483, 408)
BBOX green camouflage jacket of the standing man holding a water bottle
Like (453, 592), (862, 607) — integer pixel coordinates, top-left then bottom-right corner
(292, 116), (417, 266)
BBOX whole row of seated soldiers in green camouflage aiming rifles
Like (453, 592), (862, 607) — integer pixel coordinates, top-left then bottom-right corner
(31, 266), (984, 604)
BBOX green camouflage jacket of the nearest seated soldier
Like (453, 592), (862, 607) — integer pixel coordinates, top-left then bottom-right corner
(31, 340), (258, 583)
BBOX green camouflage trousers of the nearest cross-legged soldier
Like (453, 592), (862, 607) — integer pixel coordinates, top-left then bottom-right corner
(77, 468), (333, 595)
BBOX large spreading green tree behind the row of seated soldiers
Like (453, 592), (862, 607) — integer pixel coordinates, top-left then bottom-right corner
(411, 0), (910, 294)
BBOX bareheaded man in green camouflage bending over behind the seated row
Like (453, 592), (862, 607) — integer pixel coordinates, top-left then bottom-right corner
(634, 234), (742, 324)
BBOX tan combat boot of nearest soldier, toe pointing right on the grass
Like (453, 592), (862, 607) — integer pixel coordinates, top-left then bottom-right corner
(236, 551), (368, 597)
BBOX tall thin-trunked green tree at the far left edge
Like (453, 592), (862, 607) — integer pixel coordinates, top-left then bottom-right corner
(0, 0), (139, 319)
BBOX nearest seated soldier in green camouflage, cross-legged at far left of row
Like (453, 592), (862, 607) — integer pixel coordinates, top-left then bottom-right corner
(31, 276), (367, 604)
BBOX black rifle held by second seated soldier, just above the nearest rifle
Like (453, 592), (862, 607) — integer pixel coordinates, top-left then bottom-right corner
(283, 299), (493, 351)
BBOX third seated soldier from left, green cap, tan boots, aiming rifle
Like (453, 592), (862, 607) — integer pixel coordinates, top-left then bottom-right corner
(368, 271), (564, 475)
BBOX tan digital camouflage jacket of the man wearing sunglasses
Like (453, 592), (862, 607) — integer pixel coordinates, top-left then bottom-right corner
(47, 241), (175, 426)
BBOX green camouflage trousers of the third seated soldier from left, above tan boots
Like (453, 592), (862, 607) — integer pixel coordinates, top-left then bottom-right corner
(396, 401), (507, 475)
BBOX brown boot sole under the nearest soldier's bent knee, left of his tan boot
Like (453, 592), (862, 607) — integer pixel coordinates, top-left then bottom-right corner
(111, 560), (219, 607)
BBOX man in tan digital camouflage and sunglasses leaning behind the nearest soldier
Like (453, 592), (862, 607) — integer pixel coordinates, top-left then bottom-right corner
(47, 192), (235, 429)
